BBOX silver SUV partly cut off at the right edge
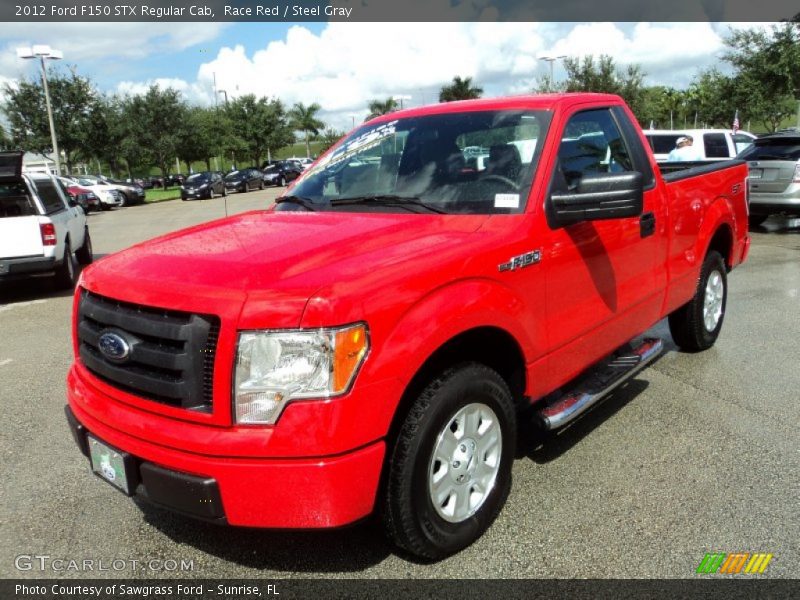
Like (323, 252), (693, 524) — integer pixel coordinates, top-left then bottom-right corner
(737, 129), (800, 225)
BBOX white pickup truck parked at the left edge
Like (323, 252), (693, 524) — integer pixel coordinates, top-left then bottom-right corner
(0, 152), (92, 288)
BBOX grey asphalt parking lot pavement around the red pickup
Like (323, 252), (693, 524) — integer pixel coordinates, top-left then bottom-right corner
(0, 210), (800, 578)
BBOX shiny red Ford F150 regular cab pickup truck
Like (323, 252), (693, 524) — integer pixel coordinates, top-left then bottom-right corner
(66, 94), (749, 559)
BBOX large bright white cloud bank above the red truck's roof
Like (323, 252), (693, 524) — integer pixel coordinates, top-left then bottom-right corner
(191, 23), (760, 128)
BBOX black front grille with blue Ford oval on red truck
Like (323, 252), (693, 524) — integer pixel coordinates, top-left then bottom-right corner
(78, 290), (220, 412)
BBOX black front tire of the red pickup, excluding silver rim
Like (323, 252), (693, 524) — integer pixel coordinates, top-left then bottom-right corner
(380, 363), (516, 560)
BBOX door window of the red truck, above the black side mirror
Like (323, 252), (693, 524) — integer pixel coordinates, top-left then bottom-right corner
(558, 109), (634, 188)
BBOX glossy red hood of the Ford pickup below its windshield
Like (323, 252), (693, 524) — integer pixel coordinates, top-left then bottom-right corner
(83, 211), (488, 327)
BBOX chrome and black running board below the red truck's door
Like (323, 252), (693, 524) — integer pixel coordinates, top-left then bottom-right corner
(535, 338), (664, 431)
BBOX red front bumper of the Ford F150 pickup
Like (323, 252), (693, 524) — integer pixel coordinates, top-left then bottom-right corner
(67, 382), (385, 529)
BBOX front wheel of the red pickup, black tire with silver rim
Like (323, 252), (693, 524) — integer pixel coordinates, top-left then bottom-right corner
(382, 363), (516, 560)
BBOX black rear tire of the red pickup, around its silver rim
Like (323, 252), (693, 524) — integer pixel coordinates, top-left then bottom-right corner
(669, 250), (728, 352)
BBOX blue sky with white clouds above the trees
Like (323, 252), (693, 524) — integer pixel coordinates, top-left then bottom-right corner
(0, 22), (767, 130)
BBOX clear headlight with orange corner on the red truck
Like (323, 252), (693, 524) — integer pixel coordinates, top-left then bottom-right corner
(233, 323), (369, 425)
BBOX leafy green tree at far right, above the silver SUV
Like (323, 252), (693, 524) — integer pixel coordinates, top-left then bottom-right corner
(723, 22), (800, 131)
